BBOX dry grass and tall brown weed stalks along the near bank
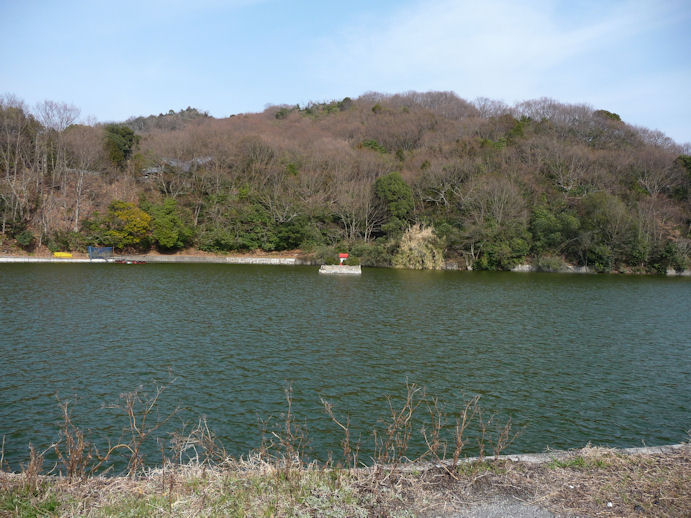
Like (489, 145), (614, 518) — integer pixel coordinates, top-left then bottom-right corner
(0, 383), (691, 517)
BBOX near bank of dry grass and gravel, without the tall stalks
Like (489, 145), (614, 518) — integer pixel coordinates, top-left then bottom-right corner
(0, 444), (691, 517)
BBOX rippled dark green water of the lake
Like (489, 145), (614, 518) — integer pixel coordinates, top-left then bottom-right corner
(0, 264), (691, 472)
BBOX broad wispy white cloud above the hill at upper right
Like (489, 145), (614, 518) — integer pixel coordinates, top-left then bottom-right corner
(312, 0), (691, 142)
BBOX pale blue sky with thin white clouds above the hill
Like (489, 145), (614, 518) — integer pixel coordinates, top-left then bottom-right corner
(0, 0), (691, 144)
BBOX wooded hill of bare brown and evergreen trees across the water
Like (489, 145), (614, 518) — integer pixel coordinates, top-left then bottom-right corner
(0, 92), (691, 271)
